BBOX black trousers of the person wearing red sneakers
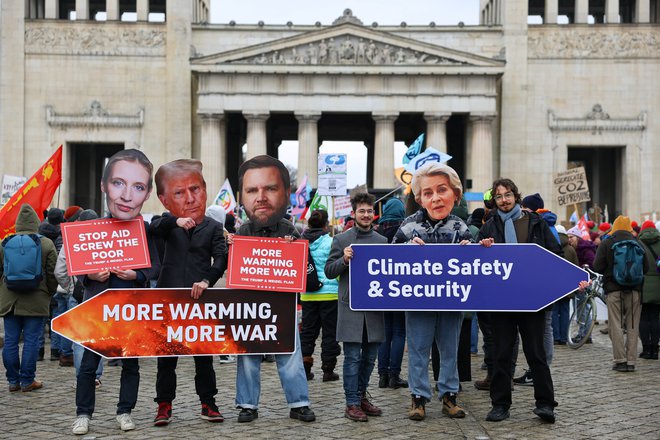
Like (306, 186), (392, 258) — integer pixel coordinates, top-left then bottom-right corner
(154, 356), (218, 405)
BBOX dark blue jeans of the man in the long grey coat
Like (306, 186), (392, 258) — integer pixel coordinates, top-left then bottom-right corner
(344, 338), (381, 406)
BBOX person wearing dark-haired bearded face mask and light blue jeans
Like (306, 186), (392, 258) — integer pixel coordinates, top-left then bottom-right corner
(227, 155), (316, 423)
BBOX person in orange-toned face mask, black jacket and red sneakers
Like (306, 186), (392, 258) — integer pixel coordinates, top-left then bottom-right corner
(151, 159), (227, 426)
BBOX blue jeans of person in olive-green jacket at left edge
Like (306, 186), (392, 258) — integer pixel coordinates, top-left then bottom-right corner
(2, 315), (44, 387)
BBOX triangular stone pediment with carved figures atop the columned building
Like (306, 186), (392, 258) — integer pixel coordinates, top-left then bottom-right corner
(192, 22), (504, 73)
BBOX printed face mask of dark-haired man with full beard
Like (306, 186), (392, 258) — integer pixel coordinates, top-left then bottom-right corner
(241, 167), (291, 227)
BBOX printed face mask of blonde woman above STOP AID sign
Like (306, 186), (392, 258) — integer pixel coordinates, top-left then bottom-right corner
(101, 160), (151, 220)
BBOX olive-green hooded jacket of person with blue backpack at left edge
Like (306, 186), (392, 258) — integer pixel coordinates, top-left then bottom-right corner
(0, 204), (57, 316)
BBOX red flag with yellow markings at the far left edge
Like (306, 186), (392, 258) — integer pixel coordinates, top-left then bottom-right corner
(0, 145), (62, 239)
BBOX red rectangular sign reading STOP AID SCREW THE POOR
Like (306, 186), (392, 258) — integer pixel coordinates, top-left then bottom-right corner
(62, 217), (151, 275)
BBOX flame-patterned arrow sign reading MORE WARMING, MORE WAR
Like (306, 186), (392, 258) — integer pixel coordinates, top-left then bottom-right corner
(51, 289), (297, 358)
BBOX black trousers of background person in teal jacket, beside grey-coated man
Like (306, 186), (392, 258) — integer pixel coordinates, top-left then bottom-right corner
(300, 300), (341, 364)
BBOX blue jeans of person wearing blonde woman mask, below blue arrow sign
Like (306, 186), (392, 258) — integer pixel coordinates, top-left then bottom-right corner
(406, 312), (463, 400)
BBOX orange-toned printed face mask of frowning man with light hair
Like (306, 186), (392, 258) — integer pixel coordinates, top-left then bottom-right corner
(158, 172), (207, 224)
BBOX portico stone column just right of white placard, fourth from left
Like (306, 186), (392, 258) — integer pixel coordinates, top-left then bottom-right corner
(373, 113), (399, 189)
